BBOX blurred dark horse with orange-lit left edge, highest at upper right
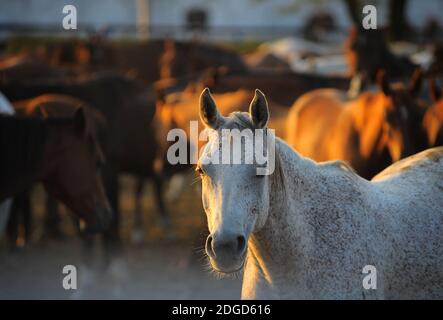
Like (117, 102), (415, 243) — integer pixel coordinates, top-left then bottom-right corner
(345, 27), (418, 83)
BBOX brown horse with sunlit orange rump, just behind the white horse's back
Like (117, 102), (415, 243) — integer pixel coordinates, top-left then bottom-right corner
(287, 72), (423, 179)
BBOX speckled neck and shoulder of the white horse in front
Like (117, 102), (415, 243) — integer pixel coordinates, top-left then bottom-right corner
(243, 141), (371, 298)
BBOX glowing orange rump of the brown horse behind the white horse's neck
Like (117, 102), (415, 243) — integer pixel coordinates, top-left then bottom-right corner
(286, 89), (345, 161)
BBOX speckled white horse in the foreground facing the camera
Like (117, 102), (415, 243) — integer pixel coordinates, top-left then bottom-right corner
(196, 89), (443, 299)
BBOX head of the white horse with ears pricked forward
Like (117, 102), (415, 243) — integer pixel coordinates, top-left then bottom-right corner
(196, 89), (273, 273)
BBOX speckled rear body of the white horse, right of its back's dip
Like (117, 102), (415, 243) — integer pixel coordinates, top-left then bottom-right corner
(372, 147), (443, 299)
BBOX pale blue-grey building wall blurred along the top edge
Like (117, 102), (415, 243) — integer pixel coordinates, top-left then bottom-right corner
(0, 0), (443, 39)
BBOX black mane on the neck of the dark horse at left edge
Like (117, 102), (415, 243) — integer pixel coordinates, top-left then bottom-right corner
(0, 115), (48, 180)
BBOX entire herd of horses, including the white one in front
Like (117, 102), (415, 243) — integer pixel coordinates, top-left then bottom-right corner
(0, 29), (443, 298)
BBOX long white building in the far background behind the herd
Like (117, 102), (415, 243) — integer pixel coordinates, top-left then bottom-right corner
(0, 0), (443, 38)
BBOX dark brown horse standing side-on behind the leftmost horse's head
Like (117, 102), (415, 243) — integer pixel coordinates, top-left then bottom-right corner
(1, 73), (168, 239)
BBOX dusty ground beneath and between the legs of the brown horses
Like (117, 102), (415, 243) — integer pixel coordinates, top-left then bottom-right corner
(0, 177), (241, 299)
